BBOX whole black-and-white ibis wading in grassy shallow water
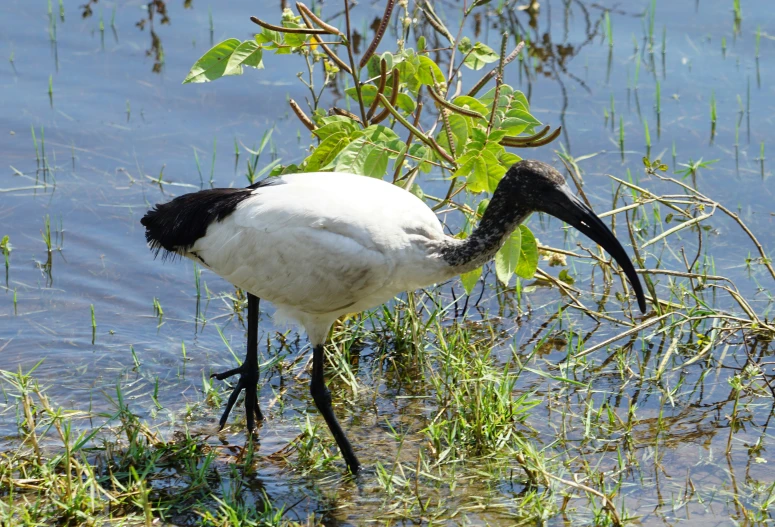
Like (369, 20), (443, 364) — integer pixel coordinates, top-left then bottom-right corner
(141, 160), (646, 474)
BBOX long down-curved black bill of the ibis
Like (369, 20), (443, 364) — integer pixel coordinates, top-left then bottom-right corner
(547, 187), (646, 314)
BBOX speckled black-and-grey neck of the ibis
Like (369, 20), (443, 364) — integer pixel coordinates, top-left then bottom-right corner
(441, 186), (530, 275)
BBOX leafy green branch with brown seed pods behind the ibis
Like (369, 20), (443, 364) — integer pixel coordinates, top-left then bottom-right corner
(184, 0), (561, 291)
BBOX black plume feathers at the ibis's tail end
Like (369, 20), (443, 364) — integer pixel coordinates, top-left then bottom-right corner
(140, 179), (273, 258)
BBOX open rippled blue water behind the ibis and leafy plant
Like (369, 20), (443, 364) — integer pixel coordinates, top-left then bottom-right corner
(0, 0), (775, 523)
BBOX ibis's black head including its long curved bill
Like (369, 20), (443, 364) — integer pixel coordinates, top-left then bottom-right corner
(504, 159), (646, 313)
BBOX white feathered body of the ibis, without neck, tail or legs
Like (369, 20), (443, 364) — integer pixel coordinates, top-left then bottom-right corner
(184, 173), (454, 342)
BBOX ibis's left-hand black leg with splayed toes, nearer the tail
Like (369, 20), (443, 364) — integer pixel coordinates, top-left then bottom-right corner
(210, 293), (264, 434)
